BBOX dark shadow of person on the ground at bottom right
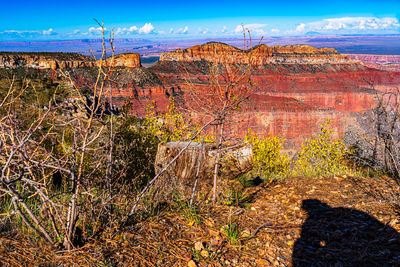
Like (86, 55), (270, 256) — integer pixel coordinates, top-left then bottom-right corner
(292, 199), (400, 266)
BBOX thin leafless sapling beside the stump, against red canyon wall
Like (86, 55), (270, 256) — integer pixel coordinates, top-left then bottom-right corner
(179, 27), (262, 203)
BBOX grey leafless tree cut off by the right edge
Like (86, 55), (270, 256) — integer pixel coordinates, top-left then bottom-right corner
(346, 77), (400, 179)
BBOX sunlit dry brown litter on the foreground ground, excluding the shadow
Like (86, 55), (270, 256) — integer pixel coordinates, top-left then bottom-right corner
(0, 177), (400, 266)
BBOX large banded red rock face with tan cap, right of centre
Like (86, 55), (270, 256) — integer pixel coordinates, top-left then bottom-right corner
(151, 43), (400, 147)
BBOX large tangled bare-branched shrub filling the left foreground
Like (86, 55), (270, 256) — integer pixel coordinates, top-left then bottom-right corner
(0, 23), (137, 250)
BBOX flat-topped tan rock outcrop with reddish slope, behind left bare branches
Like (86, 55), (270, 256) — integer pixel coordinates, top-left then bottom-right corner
(0, 52), (168, 115)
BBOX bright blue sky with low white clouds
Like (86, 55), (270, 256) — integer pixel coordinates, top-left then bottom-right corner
(0, 0), (400, 41)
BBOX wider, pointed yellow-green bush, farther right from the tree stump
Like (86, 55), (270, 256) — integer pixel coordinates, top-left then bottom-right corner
(291, 121), (350, 177)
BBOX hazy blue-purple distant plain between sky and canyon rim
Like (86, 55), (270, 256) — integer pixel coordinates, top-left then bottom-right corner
(0, 34), (400, 57)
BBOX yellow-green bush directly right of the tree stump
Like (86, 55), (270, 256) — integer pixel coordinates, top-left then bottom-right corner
(245, 130), (290, 178)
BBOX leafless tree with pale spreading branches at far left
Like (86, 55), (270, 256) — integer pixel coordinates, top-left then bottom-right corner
(0, 23), (118, 250)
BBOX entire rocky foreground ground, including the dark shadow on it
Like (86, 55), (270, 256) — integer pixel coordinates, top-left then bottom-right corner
(0, 177), (400, 267)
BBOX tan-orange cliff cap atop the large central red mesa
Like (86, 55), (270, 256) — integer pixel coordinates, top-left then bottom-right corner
(160, 42), (358, 66)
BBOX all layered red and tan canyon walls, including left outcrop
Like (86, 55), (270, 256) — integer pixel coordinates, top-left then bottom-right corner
(0, 42), (400, 147)
